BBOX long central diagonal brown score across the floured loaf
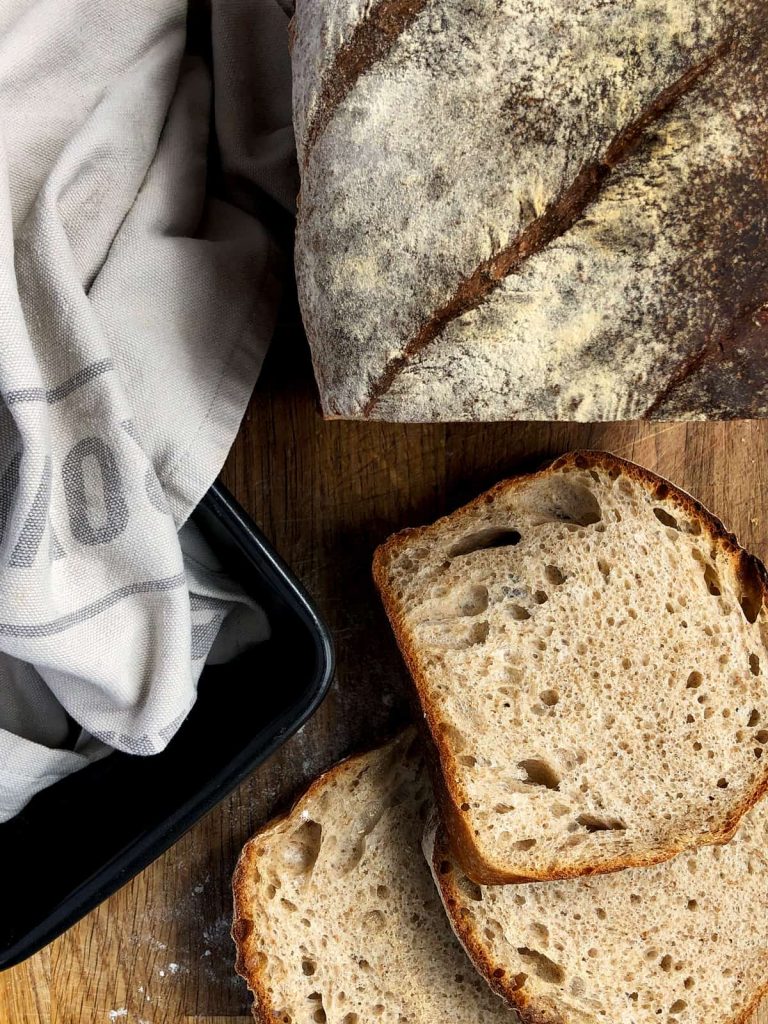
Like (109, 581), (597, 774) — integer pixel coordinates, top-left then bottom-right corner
(362, 39), (731, 417)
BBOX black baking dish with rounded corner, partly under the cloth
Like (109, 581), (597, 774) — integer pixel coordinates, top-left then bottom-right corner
(0, 484), (333, 970)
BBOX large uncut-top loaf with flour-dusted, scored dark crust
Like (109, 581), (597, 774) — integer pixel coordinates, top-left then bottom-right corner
(293, 0), (768, 420)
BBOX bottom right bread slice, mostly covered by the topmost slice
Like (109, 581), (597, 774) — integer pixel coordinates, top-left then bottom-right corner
(424, 801), (768, 1024)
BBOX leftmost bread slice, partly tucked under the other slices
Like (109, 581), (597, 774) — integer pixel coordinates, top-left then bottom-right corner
(232, 730), (515, 1024)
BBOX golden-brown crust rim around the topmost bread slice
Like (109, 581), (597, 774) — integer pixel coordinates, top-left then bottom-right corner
(373, 450), (768, 884)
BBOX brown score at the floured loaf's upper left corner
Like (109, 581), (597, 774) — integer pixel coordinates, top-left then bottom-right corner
(304, 0), (427, 166)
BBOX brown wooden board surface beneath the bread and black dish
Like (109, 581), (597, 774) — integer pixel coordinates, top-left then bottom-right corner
(0, 324), (768, 1024)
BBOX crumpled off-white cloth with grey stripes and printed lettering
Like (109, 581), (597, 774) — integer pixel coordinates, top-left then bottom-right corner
(0, 0), (296, 820)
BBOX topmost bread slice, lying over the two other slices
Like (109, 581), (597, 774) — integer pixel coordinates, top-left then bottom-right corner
(374, 452), (768, 884)
